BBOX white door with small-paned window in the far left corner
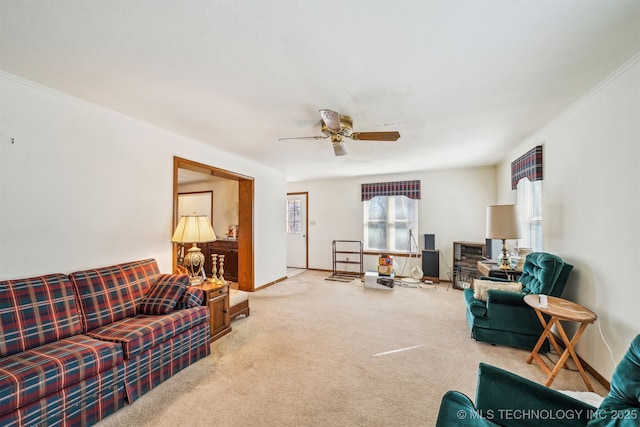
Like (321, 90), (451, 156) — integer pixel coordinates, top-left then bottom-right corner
(287, 193), (307, 268)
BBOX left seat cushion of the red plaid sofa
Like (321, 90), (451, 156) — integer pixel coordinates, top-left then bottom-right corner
(0, 335), (123, 414)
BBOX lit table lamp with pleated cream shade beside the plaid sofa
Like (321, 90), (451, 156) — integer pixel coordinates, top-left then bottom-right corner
(171, 215), (216, 281)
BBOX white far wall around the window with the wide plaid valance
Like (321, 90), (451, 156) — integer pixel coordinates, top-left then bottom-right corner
(287, 167), (496, 279)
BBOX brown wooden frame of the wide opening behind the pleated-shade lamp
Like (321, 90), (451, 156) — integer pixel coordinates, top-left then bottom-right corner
(172, 156), (255, 292)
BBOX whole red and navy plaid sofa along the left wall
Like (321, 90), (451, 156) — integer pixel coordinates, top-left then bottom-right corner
(0, 259), (210, 426)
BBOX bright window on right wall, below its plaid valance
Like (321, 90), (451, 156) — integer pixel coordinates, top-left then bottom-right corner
(517, 178), (542, 251)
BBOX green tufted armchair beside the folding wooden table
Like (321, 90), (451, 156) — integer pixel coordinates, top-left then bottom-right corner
(464, 252), (573, 353)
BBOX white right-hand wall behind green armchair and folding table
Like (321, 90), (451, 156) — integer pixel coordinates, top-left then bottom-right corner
(498, 56), (640, 377)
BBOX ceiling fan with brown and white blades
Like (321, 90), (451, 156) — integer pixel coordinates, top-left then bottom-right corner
(278, 110), (400, 156)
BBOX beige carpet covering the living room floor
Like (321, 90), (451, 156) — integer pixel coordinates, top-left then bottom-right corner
(94, 271), (606, 427)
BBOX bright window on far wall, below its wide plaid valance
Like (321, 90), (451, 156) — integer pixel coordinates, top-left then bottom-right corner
(363, 196), (418, 253)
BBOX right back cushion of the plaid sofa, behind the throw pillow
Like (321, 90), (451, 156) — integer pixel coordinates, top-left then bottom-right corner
(70, 259), (160, 332)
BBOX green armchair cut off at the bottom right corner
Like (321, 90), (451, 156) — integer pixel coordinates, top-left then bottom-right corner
(436, 335), (640, 427)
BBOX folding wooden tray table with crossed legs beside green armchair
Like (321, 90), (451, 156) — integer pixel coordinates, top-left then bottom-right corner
(524, 295), (598, 391)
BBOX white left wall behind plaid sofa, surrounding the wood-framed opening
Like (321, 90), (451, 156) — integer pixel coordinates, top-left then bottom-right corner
(0, 73), (286, 287)
